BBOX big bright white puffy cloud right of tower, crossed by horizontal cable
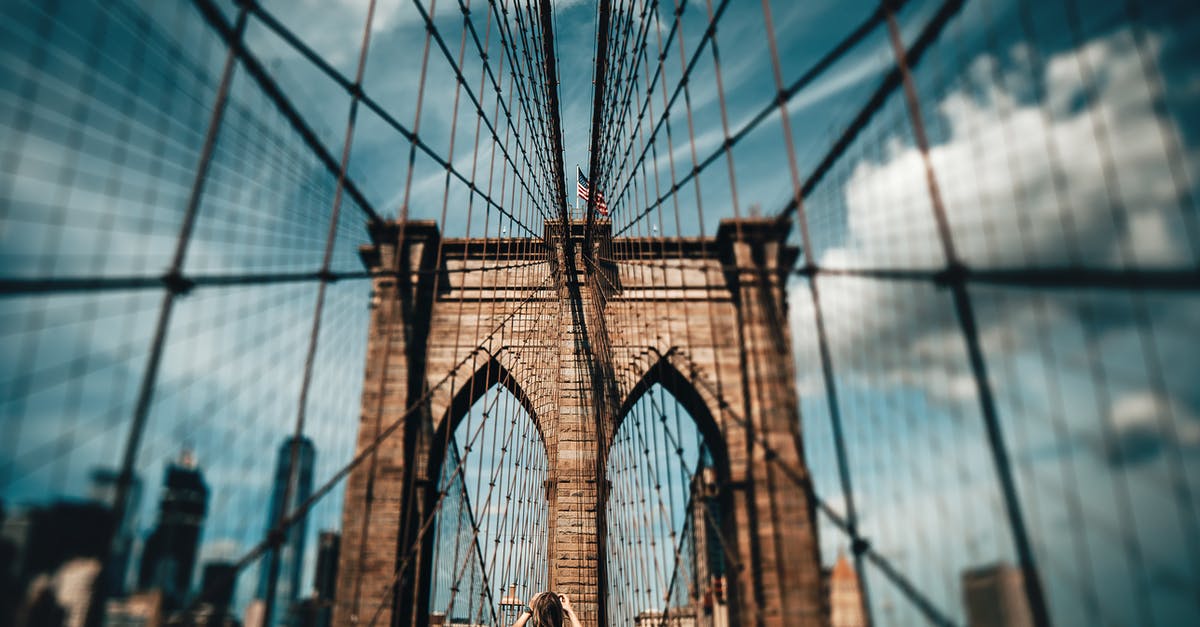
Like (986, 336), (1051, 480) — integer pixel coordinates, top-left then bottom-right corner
(791, 32), (1194, 408)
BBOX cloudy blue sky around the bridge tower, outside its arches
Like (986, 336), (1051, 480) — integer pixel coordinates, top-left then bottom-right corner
(0, 0), (1200, 625)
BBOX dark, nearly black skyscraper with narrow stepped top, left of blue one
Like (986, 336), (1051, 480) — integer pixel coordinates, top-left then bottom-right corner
(138, 450), (209, 608)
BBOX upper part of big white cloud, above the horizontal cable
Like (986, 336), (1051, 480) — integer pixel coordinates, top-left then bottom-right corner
(820, 32), (1189, 267)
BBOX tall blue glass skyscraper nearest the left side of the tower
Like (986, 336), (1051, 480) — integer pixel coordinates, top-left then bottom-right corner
(256, 436), (317, 626)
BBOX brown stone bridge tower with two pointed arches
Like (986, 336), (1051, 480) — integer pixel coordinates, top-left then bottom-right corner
(334, 219), (827, 626)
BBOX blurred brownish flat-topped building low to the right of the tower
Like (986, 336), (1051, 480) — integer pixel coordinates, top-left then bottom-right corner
(962, 563), (1033, 627)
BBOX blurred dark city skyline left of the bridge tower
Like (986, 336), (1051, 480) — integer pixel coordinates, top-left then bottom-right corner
(0, 436), (338, 625)
